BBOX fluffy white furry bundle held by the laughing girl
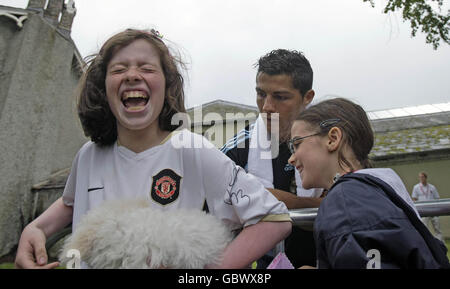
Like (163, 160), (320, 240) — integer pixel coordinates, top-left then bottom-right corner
(60, 200), (232, 269)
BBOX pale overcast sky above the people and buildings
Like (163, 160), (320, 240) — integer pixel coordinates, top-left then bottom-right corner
(0, 0), (450, 111)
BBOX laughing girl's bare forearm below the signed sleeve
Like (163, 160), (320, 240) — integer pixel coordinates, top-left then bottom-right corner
(211, 222), (292, 269)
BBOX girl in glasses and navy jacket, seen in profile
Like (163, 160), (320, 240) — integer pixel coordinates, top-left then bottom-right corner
(289, 98), (450, 269)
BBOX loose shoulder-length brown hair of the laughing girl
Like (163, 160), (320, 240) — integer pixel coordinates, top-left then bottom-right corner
(78, 29), (186, 145)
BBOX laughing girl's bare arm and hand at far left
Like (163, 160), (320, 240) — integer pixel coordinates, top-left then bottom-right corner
(15, 198), (73, 269)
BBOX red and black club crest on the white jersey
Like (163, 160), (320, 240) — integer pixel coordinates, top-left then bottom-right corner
(151, 169), (181, 205)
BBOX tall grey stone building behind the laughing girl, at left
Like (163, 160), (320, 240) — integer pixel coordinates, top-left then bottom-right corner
(0, 0), (86, 258)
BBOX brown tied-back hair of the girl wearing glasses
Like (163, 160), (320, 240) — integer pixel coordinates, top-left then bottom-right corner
(296, 98), (374, 171)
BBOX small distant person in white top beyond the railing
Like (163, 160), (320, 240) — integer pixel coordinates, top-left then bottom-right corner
(411, 172), (444, 242)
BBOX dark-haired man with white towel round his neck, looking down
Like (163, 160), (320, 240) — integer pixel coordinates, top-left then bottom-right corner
(222, 49), (322, 269)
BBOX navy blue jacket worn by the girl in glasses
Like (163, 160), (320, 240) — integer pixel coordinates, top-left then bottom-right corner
(314, 173), (450, 269)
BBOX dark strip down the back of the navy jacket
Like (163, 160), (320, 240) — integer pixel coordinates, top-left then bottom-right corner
(333, 173), (450, 269)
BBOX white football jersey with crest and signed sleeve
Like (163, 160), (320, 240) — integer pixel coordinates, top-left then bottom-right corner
(63, 129), (290, 230)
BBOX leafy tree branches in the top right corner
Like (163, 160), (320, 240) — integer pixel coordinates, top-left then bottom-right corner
(363, 0), (450, 49)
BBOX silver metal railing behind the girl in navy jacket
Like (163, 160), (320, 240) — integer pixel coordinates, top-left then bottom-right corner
(289, 199), (450, 230)
